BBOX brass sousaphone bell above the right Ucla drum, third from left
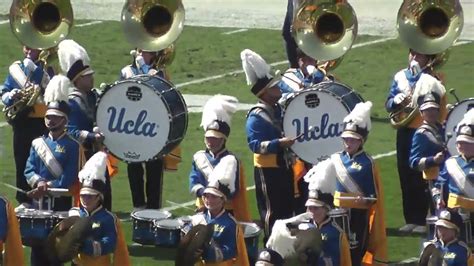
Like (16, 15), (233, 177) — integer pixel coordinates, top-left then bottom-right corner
(293, 0), (357, 61)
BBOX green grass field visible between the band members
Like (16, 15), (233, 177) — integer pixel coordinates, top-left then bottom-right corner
(0, 21), (474, 265)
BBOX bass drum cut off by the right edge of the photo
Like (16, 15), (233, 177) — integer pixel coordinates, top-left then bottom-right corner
(445, 98), (474, 155)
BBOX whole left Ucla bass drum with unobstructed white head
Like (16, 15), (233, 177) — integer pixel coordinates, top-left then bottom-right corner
(96, 75), (188, 163)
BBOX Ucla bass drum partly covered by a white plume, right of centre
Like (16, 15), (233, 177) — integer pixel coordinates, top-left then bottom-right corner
(283, 82), (364, 164)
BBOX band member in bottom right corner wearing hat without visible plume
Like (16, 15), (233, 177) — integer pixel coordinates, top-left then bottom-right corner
(420, 209), (474, 266)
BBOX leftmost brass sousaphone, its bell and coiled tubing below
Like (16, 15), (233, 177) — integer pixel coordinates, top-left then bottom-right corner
(3, 0), (73, 122)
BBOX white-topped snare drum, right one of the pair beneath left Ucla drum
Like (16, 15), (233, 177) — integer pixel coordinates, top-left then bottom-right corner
(155, 219), (183, 247)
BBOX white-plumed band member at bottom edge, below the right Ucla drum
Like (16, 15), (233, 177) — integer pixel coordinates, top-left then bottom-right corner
(304, 159), (351, 266)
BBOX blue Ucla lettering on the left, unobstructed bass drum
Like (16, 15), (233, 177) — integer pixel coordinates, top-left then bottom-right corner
(107, 106), (159, 137)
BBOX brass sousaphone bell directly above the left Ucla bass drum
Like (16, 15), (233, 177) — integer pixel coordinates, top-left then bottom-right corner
(121, 0), (184, 51)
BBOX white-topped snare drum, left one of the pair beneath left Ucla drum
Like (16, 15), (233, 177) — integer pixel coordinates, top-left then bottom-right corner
(132, 209), (171, 245)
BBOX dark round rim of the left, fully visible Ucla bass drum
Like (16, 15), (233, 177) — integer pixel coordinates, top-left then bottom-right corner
(95, 74), (189, 163)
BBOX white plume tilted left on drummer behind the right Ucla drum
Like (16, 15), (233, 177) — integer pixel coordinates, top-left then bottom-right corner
(240, 49), (272, 85)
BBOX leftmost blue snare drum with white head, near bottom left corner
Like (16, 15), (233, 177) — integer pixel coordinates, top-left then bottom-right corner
(16, 209), (54, 246)
